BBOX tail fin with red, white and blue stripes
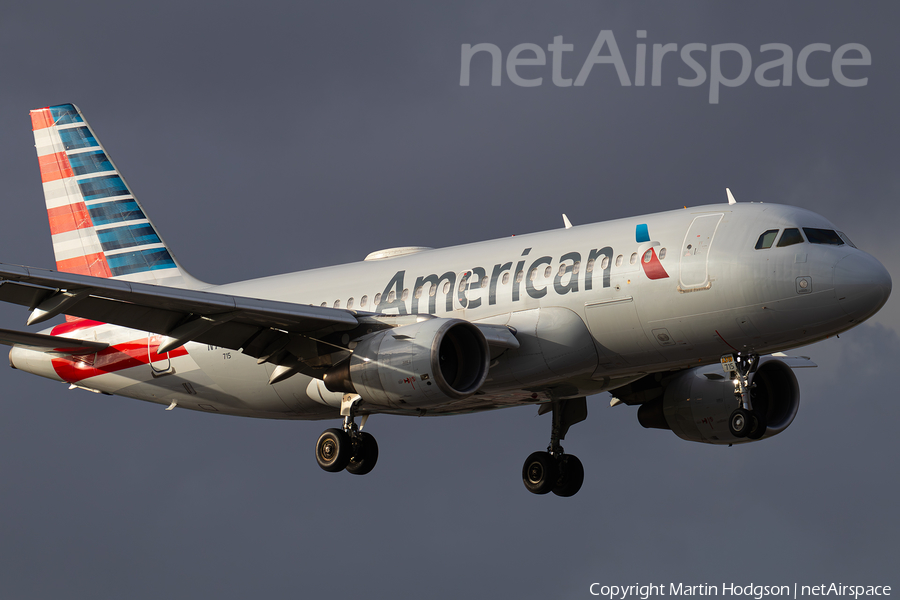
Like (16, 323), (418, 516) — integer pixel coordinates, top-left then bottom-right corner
(31, 104), (206, 288)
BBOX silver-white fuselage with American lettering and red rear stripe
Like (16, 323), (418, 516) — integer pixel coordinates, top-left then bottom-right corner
(10, 203), (891, 419)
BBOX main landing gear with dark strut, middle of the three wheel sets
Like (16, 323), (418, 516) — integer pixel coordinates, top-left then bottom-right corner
(522, 398), (587, 497)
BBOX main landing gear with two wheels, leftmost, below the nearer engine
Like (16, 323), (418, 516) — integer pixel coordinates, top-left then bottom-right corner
(316, 394), (378, 475)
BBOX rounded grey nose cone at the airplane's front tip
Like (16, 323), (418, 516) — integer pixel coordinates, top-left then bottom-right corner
(834, 252), (891, 321)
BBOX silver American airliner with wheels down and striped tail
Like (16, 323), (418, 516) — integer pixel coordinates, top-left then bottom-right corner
(0, 104), (892, 497)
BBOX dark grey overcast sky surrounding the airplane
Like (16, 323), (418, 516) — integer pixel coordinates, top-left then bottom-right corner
(0, 0), (900, 599)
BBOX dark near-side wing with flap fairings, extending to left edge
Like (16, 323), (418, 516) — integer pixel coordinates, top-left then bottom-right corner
(0, 263), (359, 374)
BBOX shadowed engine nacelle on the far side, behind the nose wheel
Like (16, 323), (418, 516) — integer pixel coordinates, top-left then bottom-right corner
(632, 356), (800, 444)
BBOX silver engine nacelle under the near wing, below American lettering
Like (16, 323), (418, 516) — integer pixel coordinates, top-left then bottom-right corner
(325, 318), (491, 408)
